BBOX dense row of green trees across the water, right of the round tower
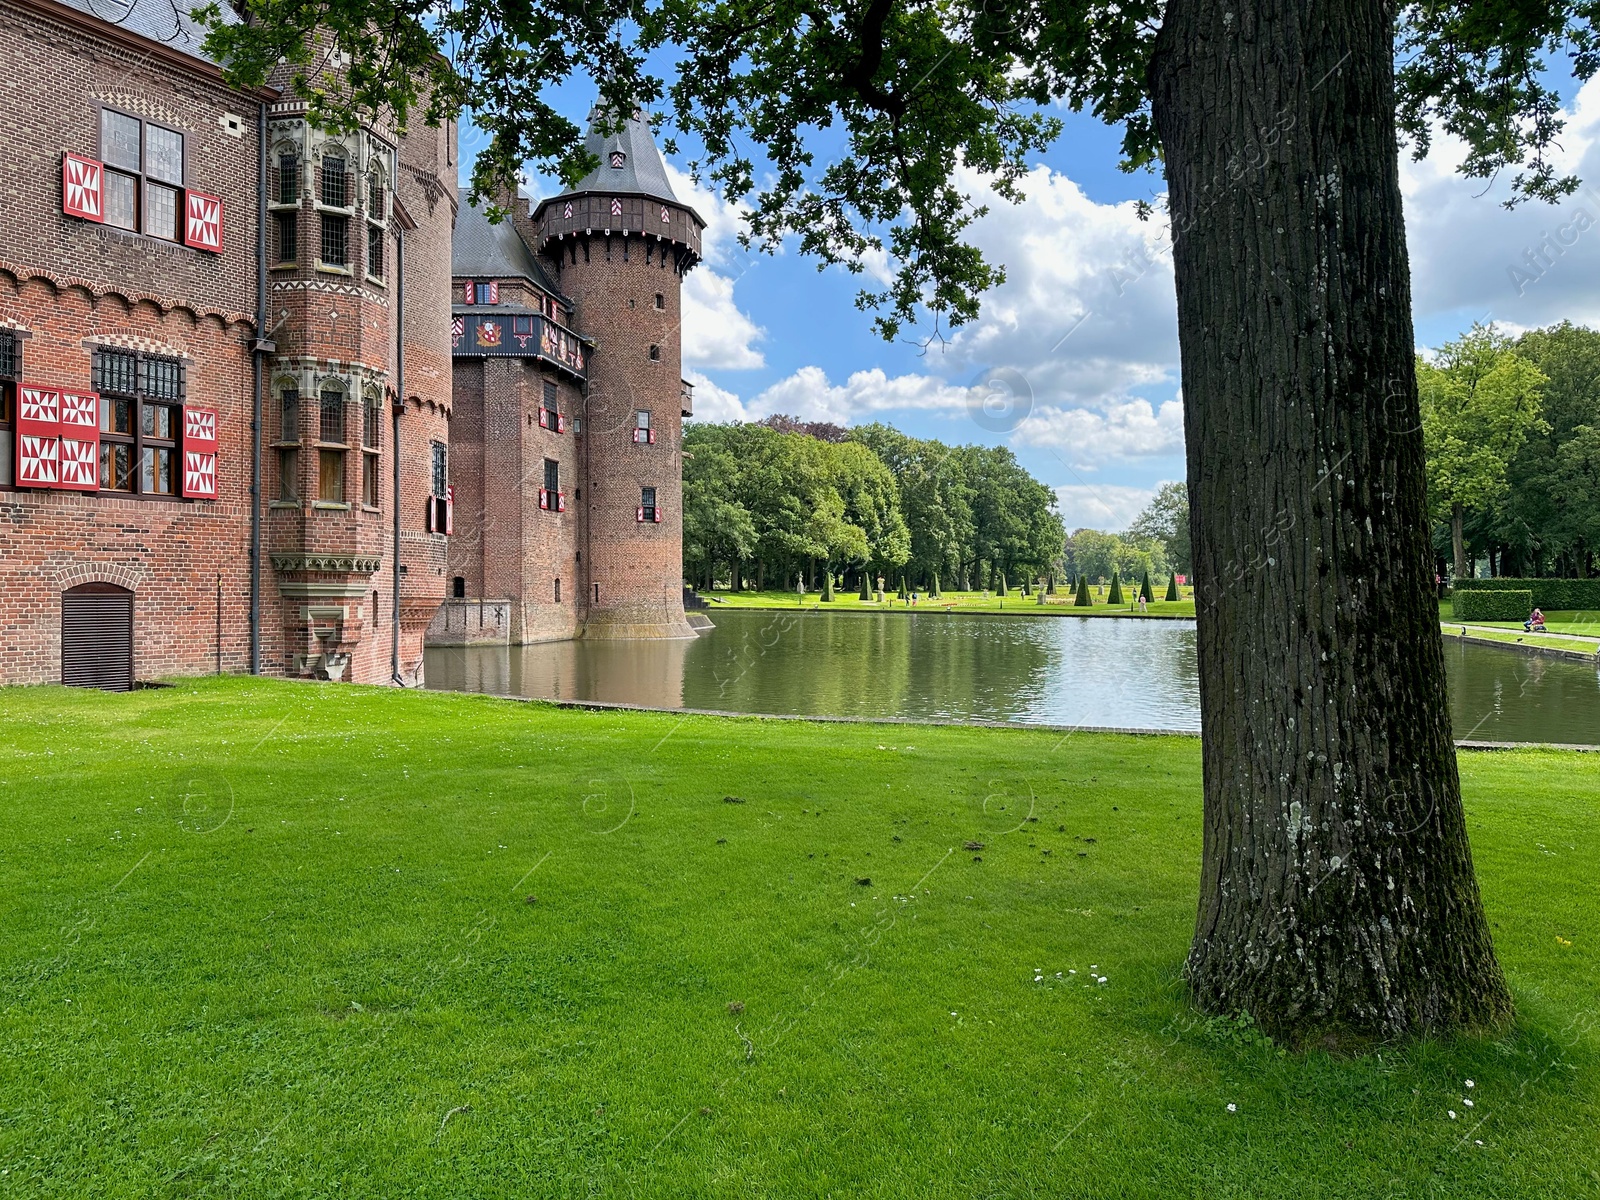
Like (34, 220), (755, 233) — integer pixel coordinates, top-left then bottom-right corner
(683, 416), (1066, 590)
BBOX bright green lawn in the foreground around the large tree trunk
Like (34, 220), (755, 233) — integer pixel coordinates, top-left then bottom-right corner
(0, 680), (1600, 1200)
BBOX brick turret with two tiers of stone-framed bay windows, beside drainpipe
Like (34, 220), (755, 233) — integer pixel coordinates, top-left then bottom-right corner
(262, 99), (456, 683)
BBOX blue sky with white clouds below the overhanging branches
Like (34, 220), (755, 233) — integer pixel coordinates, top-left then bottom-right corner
(462, 72), (1600, 530)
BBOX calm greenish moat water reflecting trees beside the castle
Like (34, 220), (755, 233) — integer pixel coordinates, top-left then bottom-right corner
(427, 608), (1600, 744)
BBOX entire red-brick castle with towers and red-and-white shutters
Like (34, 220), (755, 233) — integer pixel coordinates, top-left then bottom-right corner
(0, 0), (702, 688)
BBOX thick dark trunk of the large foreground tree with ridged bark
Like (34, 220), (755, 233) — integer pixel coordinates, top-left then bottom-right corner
(1152, 0), (1510, 1043)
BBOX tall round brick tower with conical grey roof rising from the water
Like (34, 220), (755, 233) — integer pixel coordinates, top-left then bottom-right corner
(528, 109), (706, 638)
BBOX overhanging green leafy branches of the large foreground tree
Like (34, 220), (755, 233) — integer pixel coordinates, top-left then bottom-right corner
(208, 0), (1600, 336)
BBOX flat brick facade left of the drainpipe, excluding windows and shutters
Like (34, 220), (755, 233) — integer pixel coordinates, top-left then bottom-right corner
(0, 8), (256, 683)
